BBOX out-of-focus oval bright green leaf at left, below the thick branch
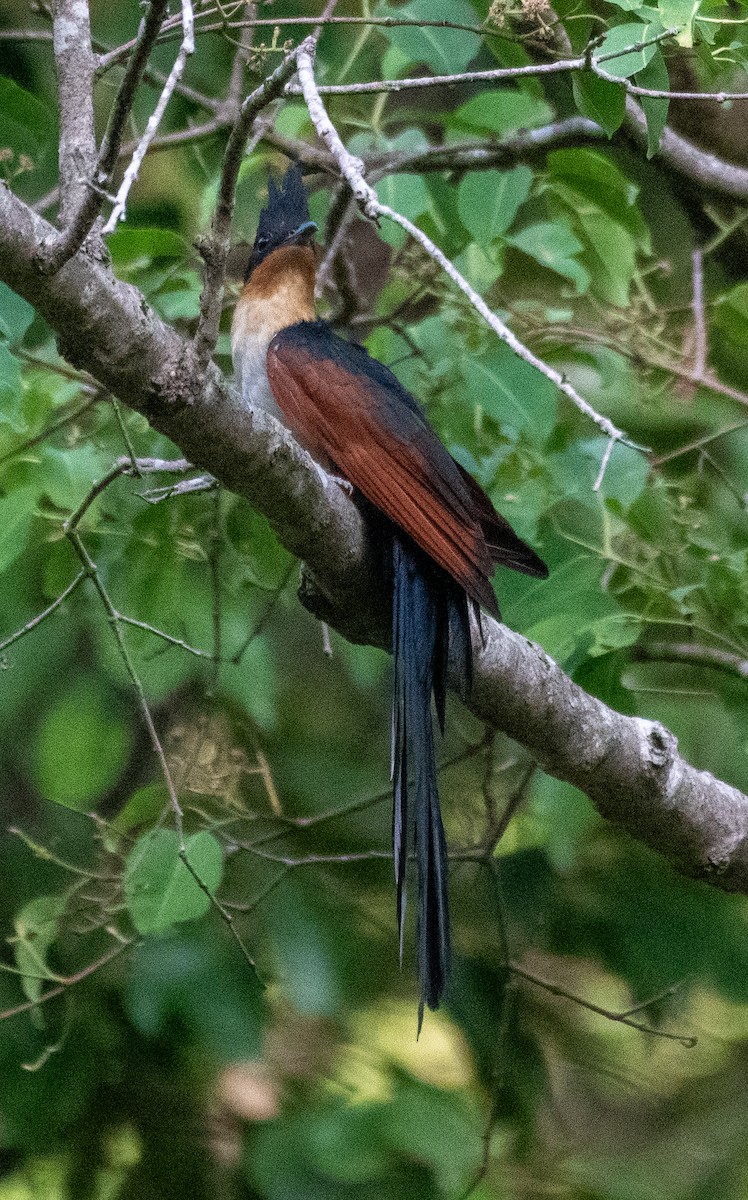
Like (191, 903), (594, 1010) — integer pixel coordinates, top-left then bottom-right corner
(31, 677), (130, 811)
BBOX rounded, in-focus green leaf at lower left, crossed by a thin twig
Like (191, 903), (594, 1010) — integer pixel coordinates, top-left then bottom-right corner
(125, 829), (223, 934)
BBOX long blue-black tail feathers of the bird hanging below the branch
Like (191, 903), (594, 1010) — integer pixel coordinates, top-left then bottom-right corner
(393, 535), (471, 1028)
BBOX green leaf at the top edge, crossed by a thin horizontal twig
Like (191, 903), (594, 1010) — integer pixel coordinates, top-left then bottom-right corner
(375, 0), (480, 74)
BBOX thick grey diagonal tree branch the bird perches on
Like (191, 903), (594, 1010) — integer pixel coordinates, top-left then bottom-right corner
(0, 186), (748, 894)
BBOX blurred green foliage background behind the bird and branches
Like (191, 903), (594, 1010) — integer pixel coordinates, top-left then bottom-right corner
(0, 0), (748, 1200)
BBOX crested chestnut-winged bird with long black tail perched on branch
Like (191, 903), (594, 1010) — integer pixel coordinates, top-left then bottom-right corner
(232, 163), (547, 1032)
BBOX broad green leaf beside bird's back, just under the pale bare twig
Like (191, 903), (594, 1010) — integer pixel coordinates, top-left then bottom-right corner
(462, 342), (557, 445)
